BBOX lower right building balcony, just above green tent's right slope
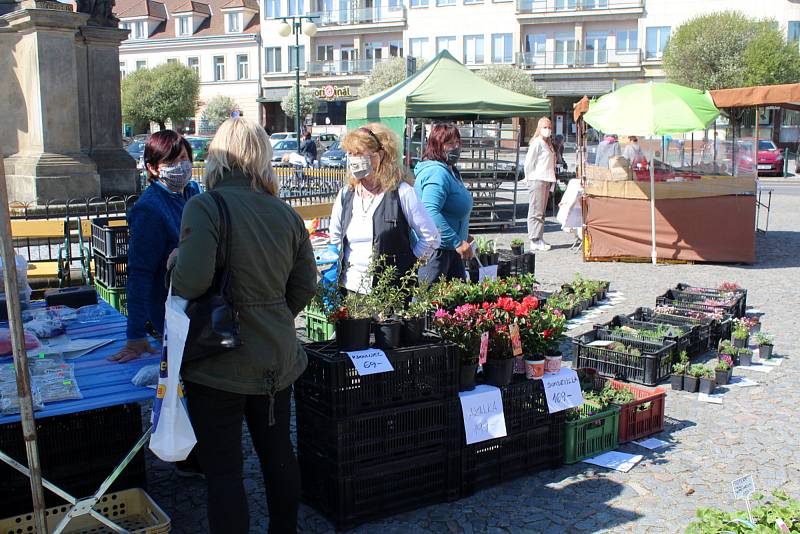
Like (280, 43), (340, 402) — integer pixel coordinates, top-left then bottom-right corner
(517, 49), (642, 74)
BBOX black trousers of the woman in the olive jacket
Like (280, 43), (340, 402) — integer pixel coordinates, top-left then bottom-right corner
(185, 382), (300, 534)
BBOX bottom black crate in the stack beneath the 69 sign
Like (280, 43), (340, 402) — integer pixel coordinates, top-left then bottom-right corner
(298, 447), (459, 530)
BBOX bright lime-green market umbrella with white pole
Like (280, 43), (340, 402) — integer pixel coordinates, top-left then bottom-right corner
(583, 82), (719, 265)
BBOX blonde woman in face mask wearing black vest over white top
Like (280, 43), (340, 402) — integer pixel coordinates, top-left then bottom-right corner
(329, 123), (440, 292)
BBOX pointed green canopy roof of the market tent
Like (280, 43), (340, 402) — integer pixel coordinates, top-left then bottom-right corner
(347, 50), (550, 121)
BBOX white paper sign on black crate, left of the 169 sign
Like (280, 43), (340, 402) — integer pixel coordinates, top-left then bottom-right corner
(458, 385), (507, 445)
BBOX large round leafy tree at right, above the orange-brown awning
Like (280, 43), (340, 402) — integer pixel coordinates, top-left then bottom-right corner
(664, 11), (800, 90)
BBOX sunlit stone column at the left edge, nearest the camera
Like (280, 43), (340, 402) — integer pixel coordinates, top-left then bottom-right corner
(0, 5), (101, 202)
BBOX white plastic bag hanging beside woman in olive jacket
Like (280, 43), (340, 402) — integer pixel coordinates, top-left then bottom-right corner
(150, 287), (197, 462)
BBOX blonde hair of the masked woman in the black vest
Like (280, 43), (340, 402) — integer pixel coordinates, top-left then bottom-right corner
(341, 122), (410, 191)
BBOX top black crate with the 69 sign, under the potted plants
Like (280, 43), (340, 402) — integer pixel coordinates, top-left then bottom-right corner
(295, 339), (459, 417)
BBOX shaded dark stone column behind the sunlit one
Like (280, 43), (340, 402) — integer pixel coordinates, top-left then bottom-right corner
(76, 26), (136, 196)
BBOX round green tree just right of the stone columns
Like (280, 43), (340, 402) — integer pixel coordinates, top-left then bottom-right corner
(122, 63), (200, 130)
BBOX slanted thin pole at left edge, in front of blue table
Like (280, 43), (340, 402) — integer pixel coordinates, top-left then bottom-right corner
(0, 155), (47, 534)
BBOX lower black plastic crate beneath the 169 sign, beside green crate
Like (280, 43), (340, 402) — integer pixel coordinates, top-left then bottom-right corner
(459, 420), (564, 497)
